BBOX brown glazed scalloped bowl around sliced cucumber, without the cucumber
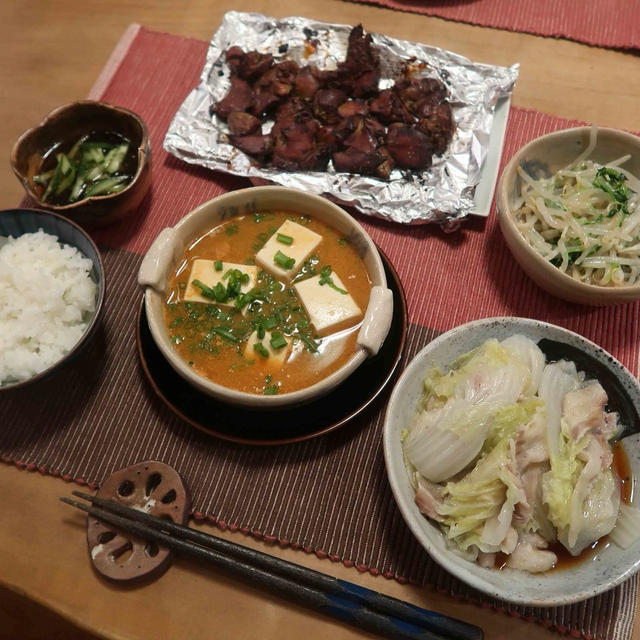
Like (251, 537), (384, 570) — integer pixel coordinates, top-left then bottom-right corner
(11, 100), (151, 228)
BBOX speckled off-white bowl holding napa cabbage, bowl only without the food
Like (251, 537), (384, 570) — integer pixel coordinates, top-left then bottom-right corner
(384, 318), (640, 606)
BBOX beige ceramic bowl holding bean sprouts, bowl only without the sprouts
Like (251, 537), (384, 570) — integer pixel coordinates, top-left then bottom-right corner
(496, 127), (640, 306)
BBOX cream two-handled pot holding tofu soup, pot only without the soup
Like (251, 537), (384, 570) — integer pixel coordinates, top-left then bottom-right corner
(138, 187), (393, 409)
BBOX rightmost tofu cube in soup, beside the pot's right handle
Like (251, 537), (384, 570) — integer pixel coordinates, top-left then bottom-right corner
(293, 272), (362, 336)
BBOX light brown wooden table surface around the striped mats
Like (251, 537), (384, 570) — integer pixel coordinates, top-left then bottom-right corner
(0, 0), (640, 640)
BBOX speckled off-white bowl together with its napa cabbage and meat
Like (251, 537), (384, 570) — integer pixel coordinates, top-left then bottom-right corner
(383, 318), (640, 606)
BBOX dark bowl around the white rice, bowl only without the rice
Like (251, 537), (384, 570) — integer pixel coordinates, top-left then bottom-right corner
(0, 209), (106, 392)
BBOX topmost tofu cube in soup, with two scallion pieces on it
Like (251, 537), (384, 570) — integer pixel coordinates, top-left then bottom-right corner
(256, 220), (322, 282)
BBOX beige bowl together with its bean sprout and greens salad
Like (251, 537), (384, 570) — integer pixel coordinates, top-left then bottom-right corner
(497, 127), (640, 306)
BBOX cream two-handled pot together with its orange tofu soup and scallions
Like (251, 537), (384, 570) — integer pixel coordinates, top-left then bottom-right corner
(138, 187), (393, 408)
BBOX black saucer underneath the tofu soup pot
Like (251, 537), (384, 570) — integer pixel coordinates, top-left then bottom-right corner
(136, 251), (407, 445)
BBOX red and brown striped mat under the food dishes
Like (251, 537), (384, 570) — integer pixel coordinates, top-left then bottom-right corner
(0, 28), (640, 640)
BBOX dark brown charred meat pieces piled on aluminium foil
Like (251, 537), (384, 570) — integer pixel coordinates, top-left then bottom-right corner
(212, 25), (455, 180)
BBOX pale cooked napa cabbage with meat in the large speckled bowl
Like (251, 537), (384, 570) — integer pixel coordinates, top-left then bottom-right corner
(403, 335), (628, 572)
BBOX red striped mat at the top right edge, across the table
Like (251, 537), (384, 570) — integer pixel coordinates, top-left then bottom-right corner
(350, 0), (640, 49)
